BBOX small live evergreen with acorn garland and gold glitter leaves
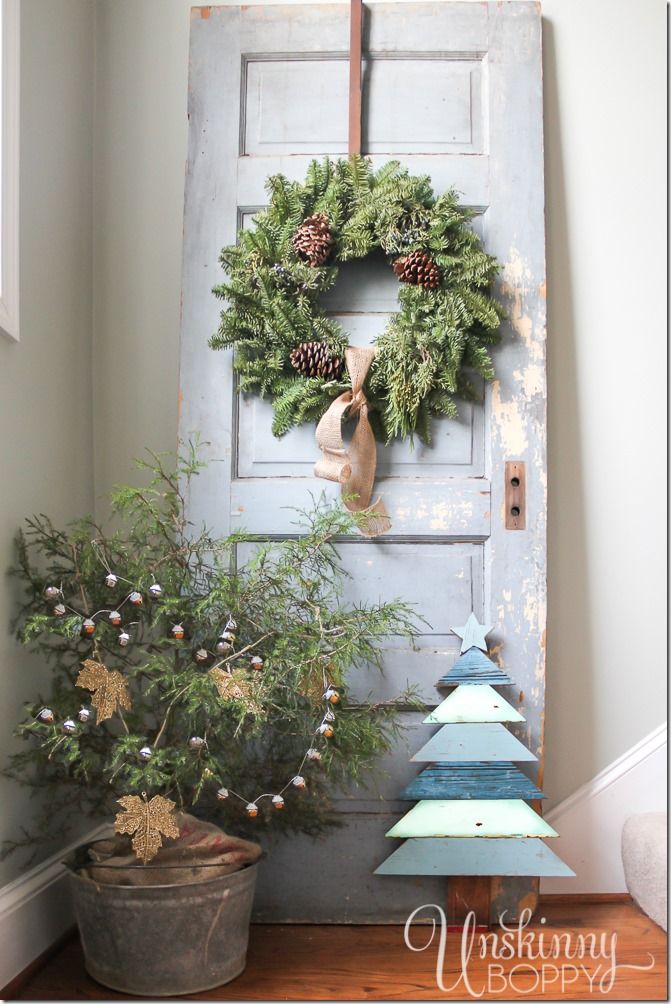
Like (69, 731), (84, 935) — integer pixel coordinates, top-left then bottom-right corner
(5, 449), (412, 852)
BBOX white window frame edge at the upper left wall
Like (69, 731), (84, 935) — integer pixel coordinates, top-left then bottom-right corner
(0, 0), (20, 341)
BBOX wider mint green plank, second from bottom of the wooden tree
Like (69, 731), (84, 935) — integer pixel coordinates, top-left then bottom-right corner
(386, 798), (558, 837)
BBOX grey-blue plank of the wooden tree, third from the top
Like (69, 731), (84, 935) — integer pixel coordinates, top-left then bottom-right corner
(411, 722), (536, 763)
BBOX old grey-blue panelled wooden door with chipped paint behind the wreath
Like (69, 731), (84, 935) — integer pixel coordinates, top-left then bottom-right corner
(181, 2), (545, 923)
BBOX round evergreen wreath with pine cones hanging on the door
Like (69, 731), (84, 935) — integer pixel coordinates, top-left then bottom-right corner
(210, 156), (504, 443)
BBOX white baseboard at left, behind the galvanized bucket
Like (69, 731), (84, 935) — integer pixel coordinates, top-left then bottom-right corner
(0, 824), (109, 987)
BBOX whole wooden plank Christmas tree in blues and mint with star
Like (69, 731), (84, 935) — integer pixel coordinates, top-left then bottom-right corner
(376, 613), (574, 926)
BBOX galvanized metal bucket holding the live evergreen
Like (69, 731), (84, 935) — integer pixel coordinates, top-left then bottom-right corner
(66, 862), (257, 997)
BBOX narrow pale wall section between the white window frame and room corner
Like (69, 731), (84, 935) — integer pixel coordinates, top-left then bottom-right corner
(0, 0), (94, 883)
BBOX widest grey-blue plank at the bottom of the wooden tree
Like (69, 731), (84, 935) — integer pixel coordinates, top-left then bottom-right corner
(375, 836), (575, 877)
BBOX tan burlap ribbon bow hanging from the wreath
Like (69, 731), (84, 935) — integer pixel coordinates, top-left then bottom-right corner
(314, 348), (392, 537)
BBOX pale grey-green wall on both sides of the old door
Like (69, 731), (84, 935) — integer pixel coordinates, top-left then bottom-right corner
(0, 0), (666, 876)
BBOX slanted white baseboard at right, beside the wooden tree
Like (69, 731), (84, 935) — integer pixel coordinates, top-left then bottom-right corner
(540, 723), (667, 894)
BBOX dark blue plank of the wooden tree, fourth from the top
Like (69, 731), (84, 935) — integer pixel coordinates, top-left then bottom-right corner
(399, 760), (545, 802)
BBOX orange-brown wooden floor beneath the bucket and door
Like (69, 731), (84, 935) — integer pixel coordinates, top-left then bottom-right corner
(5, 898), (667, 1001)
